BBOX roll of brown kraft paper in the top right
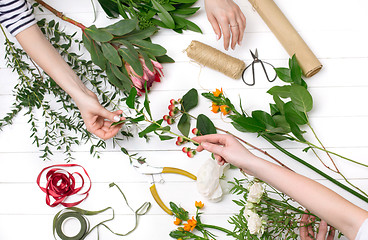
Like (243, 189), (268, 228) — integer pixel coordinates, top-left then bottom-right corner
(249, 0), (322, 77)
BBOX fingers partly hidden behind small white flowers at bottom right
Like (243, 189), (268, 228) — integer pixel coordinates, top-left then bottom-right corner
(299, 214), (335, 240)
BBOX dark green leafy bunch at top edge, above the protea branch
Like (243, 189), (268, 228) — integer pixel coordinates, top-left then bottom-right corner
(98, 0), (202, 33)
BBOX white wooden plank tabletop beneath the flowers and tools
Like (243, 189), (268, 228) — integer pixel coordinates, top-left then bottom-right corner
(0, 0), (368, 240)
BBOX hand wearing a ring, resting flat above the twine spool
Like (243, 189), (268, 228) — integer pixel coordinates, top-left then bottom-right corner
(204, 0), (246, 50)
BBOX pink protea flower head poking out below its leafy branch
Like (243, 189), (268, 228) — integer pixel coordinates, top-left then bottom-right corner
(125, 56), (164, 95)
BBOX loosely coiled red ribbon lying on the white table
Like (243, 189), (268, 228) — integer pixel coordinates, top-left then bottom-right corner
(37, 164), (92, 207)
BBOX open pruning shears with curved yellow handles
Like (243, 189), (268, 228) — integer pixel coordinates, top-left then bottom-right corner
(133, 163), (197, 215)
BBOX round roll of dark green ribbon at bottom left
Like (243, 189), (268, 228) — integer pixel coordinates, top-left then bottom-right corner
(55, 212), (88, 240)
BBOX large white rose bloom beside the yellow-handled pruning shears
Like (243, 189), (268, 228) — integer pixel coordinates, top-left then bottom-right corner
(197, 159), (228, 201)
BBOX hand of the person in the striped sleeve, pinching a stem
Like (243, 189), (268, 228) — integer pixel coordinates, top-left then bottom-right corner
(74, 90), (124, 140)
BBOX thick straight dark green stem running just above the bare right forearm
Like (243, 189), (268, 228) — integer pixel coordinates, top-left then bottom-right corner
(262, 135), (368, 203)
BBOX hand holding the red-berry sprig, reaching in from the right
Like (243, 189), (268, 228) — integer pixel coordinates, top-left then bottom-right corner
(193, 134), (255, 170)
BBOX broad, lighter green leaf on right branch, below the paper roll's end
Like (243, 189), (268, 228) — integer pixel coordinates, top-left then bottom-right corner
(290, 85), (313, 113)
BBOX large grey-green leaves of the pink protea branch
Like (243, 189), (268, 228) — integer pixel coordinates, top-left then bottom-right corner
(82, 18), (173, 91)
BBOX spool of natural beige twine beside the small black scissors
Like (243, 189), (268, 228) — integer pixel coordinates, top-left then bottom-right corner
(185, 40), (245, 79)
